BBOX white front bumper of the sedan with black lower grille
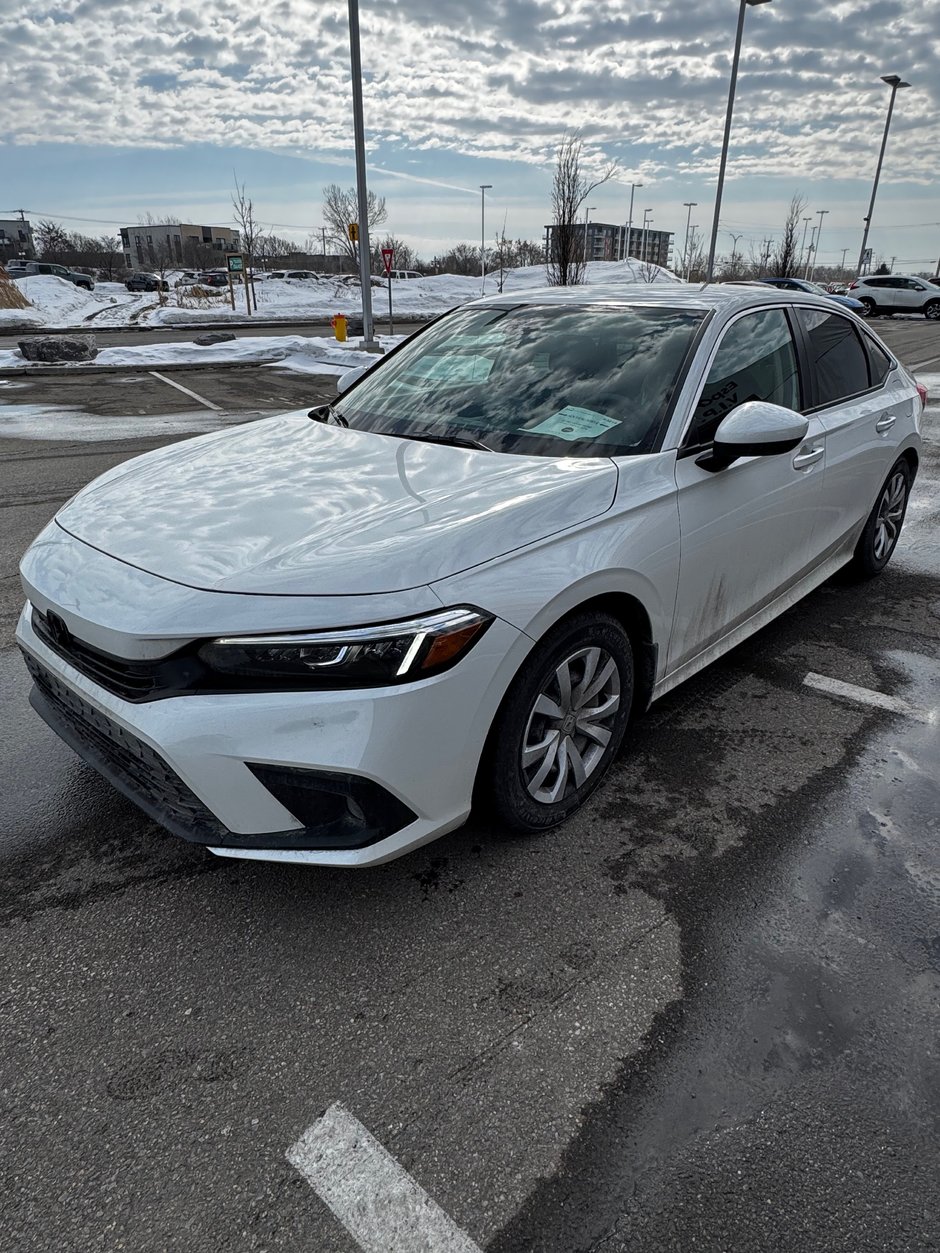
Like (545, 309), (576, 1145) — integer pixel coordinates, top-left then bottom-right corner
(16, 604), (530, 866)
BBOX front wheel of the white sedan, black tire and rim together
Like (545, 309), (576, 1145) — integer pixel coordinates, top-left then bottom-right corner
(481, 613), (634, 832)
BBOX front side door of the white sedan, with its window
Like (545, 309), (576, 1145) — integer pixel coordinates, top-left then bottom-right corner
(668, 308), (826, 670)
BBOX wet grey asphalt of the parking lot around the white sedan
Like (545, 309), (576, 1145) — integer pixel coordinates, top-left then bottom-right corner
(0, 321), (940, 1253)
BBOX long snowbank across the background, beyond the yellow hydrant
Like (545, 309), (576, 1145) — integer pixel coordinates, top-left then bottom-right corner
(0, 261), (681, 331)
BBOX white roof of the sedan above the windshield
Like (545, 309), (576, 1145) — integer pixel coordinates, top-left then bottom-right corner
(473, 283), (832, 313)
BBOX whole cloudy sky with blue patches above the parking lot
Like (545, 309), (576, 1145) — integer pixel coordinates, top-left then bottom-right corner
(0, 0), (940, 271)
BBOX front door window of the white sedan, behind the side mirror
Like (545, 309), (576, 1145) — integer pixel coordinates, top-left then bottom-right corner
(686, 309), (801, 445)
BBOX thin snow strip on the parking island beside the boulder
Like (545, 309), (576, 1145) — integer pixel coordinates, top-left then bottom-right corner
(0, 335), (404, 375)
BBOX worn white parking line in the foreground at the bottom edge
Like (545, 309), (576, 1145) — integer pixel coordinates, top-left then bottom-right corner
(287, 1104), (480, 1253)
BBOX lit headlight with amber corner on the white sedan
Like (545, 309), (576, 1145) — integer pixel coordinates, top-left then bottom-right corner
(199, 608), (493, 688)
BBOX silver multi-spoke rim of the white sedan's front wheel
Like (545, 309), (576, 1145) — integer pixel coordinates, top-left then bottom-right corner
(521, 645), (620, 804)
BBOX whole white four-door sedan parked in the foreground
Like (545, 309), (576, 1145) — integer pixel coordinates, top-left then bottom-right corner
(18, 286), (926, 866)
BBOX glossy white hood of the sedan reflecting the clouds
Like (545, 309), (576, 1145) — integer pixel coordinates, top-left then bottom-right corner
(56, 411), (617, 595)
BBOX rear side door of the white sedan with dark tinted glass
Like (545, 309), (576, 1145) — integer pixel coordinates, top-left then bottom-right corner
(796, 307), (914, 553)
